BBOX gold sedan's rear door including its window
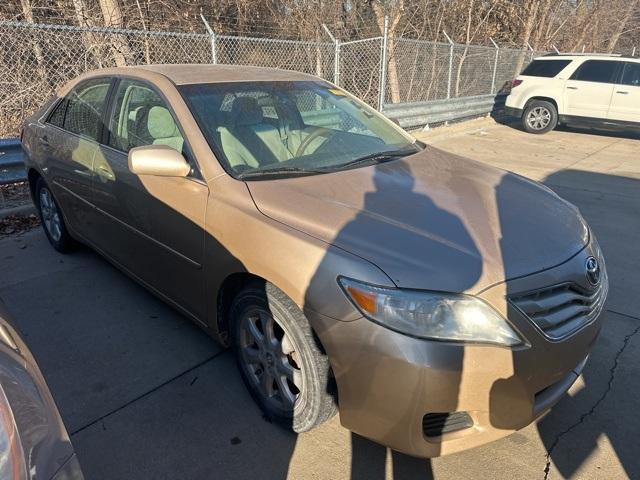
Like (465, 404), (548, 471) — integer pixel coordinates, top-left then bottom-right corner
(39, 78), (111, 236)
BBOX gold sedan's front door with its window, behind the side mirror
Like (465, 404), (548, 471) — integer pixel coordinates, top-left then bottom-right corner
(93, 79), (209, 321)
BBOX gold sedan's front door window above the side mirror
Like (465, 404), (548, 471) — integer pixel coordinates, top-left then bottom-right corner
(109, 80), (184, 153)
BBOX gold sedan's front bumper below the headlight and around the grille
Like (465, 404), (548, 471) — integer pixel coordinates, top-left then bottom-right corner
(307, 244), (602, 457)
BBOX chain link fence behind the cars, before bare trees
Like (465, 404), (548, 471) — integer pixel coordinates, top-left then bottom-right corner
(0, 21), (534, 137)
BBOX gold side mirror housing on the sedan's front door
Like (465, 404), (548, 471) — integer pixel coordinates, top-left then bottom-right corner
(129, 145), (191, 177)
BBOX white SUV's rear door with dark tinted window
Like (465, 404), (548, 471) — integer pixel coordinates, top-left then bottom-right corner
(564, 60), (621, 119)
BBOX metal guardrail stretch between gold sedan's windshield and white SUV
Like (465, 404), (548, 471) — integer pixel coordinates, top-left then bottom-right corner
(382, 94), (506, 129)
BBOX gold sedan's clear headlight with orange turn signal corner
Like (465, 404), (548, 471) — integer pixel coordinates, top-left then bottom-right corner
(338, 277), (524, 346)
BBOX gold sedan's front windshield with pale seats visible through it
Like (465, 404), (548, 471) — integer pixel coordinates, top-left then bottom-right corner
(180, 81), (420, 180)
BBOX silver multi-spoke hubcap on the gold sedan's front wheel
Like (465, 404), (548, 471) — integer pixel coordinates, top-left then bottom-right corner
(239, 309), (304, 413)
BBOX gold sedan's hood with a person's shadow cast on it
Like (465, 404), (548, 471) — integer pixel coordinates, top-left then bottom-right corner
(247, 147), (588, 293)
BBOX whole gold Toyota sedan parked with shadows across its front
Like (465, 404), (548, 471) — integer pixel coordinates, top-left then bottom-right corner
(22, 65), (608, 457)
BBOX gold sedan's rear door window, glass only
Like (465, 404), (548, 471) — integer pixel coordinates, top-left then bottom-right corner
(63, 78), (111, 140)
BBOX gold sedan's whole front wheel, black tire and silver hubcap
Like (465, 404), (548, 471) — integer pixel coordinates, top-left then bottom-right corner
(230, 282), (337, 433)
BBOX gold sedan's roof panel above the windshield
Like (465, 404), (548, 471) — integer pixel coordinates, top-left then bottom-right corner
(109, 64), (319, 85)
